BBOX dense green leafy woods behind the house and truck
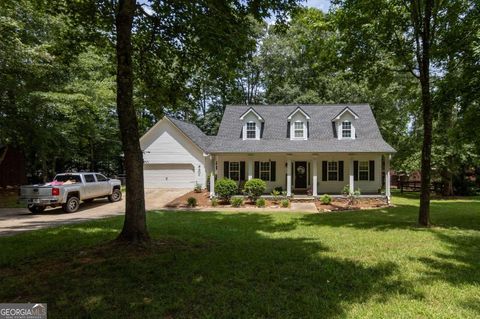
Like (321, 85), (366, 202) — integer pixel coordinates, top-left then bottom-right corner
(0, 0), (480, 195)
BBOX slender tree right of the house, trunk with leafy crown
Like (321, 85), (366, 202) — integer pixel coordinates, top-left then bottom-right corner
(334, 0), (476, 226)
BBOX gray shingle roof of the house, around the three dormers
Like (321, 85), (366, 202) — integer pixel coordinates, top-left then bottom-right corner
(169, 104), (395, 153)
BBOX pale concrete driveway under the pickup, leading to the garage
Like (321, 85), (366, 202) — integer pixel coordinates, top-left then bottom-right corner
(0, 189), (190, 236)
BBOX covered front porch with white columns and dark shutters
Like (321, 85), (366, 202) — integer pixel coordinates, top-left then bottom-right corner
(209, 153), (390, 200)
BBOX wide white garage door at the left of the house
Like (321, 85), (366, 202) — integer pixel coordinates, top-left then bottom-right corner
(143, 164), (195, 189)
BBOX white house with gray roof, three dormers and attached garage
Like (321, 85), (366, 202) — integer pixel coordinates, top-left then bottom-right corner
(140, 104), (395, 198)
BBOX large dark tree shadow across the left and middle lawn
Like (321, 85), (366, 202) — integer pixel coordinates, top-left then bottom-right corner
(0, 212), (418, 318)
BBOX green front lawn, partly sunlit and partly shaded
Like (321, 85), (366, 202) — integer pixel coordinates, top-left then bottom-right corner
(0, 194), (480, 318)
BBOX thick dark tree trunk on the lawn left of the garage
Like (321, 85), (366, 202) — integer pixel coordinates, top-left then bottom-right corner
(116, 0), (150, 243)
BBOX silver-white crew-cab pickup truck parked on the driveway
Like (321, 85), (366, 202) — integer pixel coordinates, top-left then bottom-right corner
(19, 173), (122, 214)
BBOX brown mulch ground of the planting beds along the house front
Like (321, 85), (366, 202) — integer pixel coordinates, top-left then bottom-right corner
(166, 190), (388, 212)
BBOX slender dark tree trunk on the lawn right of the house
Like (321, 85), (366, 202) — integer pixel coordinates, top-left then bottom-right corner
(417, 0), (433, 227)
